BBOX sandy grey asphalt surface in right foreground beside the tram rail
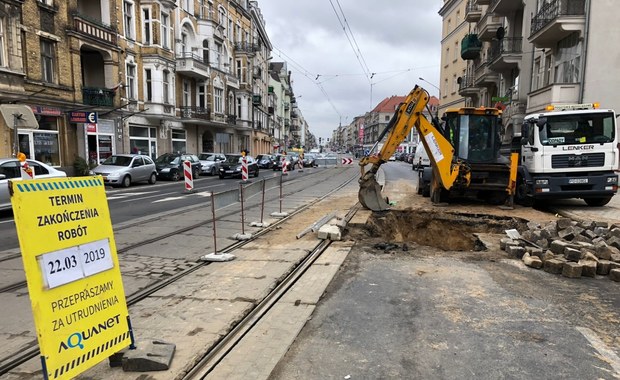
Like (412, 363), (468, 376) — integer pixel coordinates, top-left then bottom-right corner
(270, 163), (620, 380)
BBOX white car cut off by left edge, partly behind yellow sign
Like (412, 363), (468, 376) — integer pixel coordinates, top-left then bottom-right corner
(0, 158), (67, 210)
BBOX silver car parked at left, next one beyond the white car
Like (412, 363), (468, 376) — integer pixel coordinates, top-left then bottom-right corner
(92, 154), (157, 187)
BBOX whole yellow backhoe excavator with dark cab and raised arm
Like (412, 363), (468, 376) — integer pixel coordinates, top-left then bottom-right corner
(358, 86), (518, 211)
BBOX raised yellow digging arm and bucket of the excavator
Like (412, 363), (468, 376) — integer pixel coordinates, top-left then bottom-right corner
(358, 86), (469, 211)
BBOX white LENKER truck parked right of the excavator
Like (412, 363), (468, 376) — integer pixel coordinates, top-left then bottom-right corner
(515, 103), (620, 207)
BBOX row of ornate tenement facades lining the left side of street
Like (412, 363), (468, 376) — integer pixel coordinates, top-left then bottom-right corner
(0, 0), (292, 174)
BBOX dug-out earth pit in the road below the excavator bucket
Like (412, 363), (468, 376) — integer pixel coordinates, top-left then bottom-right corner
(365, 210), (527, 251)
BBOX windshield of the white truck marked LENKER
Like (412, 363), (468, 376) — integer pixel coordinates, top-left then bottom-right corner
(540, 112), (616, 145)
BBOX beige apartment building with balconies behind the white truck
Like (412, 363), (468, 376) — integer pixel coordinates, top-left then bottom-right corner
(440, 0), (620, 144)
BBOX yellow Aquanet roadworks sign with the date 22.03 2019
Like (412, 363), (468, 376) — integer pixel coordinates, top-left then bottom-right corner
(9, 177), (132, 379)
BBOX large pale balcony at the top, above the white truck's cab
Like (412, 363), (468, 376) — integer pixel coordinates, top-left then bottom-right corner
(528, 0), (586, 48)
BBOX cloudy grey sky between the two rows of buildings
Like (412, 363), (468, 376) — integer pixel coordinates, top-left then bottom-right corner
(258, 0), (441, 142)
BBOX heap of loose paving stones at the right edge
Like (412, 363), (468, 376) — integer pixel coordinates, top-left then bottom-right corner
(500, 218), (620, 282)
